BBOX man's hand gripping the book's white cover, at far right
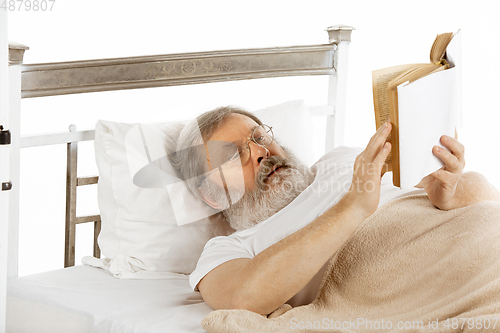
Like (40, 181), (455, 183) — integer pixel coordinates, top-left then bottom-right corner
(416, 135), (465, 210)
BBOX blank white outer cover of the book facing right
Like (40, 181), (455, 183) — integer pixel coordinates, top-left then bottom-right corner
(398, 68), (457, 189)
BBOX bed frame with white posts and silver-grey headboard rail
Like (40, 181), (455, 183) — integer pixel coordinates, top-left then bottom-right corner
(0, 21), (354, 332)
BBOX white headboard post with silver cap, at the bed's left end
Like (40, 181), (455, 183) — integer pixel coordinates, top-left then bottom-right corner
(7, 43), (29, 278)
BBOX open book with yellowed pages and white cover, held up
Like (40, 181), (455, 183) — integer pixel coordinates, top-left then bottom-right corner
(372, 31), (461, 188)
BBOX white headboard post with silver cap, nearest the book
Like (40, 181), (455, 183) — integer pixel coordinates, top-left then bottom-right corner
(325, 25), (354, 152)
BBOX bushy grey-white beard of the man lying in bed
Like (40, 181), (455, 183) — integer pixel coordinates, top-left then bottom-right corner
(222, 151), (314, 230)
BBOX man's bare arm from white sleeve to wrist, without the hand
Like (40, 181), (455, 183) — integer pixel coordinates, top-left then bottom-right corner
(198, 197), (364, 314)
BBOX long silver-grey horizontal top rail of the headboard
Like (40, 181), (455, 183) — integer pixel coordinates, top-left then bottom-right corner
(21, 44), (335, 98)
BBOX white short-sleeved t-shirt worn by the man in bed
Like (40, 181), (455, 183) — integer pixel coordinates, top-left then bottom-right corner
(189, 147), (425, 306)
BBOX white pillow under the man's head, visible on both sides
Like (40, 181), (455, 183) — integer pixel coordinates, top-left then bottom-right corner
(82, 101), (312, 279)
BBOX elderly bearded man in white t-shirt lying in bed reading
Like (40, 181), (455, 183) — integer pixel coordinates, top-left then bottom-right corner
(173, 107), (500, 314)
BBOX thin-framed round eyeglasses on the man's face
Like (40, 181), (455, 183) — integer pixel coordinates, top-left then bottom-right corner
(224, 124), (274, 165)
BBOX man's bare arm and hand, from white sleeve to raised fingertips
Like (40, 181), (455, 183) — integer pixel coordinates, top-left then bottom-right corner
(198, 123), (391, 314)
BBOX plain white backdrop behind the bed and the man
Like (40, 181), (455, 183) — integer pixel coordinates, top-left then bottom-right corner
(2, 0), (500, 275)
